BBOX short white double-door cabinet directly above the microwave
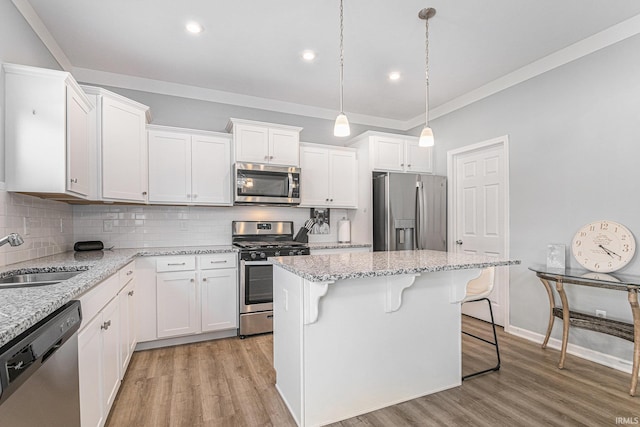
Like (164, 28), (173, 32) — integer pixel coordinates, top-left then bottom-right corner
(227, 119), (302, 166)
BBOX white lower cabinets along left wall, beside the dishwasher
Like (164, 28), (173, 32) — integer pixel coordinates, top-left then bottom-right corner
(78, 263), (135, 427)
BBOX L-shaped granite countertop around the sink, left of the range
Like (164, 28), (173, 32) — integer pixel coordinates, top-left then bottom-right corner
(0, 245), (237, 347)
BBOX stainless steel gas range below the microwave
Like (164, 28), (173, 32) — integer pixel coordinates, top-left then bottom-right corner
(231, 221), (309, 338)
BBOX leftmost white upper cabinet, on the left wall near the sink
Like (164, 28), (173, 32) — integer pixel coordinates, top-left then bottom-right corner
(4, 64), (96, 200)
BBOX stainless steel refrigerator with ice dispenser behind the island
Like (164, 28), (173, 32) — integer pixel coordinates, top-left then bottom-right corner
(373, 172), (447, 251)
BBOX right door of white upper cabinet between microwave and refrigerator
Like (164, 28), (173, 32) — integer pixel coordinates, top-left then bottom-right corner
(329, 150), (358, 208)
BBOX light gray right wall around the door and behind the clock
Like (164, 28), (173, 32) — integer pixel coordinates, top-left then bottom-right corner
(411, 36), (640, 360)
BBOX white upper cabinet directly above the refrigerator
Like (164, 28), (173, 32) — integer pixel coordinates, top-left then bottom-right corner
(369, 133), (433, 173)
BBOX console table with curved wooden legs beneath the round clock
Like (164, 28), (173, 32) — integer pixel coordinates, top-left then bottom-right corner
(529, 266), (640, 396)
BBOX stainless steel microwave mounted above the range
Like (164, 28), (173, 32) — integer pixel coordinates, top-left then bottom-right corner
(233, 163), (300, 205)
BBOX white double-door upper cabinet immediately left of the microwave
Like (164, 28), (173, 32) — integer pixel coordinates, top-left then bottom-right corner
(148, 126), (231, 206)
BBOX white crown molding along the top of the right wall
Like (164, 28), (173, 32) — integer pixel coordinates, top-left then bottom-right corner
(406, 15), (640, 130)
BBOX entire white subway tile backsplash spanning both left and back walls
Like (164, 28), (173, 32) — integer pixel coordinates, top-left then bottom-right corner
(0, 189), (347, 267)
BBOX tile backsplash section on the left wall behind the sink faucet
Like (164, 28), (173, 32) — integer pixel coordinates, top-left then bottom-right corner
(0, 190), (74, 266)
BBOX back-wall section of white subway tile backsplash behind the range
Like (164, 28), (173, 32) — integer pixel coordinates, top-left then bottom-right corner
(73, 205), (346, 248)
